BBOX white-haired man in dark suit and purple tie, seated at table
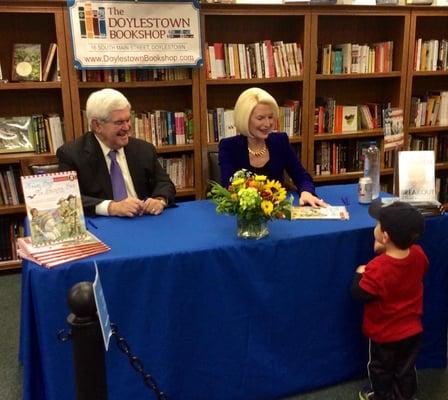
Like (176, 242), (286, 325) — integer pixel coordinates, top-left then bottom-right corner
(56, 89), (176, 217)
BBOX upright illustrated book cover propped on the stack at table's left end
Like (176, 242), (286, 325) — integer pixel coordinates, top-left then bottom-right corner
(21, 171), (87, 246)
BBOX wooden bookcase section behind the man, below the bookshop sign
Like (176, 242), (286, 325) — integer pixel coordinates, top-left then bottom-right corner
(65, 13), (202, 200)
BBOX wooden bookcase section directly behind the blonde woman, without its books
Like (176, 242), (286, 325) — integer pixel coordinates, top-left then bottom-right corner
(200, 4), (311, 195)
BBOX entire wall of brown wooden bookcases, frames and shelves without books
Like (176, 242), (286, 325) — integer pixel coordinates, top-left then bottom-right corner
(0, 0), (448, 270)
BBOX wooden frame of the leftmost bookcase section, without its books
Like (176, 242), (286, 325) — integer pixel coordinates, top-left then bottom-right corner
(0, 1), (72, 270)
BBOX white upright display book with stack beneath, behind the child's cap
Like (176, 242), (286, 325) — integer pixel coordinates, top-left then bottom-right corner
(381, 150), (445, 216)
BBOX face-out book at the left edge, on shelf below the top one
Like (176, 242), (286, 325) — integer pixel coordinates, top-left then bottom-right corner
(0, 117), (34, 153)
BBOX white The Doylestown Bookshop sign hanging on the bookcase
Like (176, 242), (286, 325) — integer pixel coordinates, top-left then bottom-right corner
(68, 0), (202, 69)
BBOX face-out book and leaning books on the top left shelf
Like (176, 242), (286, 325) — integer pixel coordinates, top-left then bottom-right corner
(8, 43), (60, 82)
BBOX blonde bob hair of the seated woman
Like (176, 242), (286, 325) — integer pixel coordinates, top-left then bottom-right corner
(233, 88), (279, 136)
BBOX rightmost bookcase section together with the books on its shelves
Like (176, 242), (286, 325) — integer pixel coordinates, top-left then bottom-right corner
(405, 7), (448, 203)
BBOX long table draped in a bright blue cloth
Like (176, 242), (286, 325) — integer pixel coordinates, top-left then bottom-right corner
(20, 185), (448, 400)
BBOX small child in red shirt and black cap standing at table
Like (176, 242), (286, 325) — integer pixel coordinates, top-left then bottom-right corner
(352, 201), (428, 400)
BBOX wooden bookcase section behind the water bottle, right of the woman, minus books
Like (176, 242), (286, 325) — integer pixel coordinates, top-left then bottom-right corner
(307, 7), (410, 189)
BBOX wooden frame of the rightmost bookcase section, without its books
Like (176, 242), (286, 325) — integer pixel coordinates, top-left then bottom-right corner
(405, 7), (448, 202)
